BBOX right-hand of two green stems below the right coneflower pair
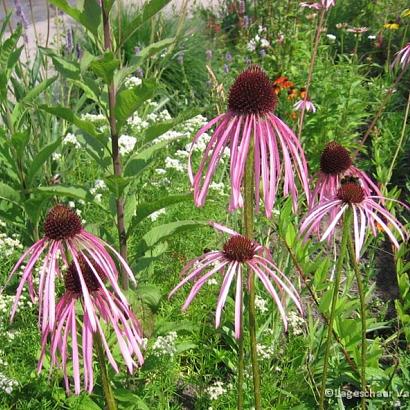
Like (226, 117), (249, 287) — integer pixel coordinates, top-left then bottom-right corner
(349, 234), (367, 410)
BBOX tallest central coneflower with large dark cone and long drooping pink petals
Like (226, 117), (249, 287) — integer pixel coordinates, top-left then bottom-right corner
(188, 65), (309, 217)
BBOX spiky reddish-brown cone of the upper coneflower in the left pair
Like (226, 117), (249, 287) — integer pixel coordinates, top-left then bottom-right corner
(44, 205), (82, 240)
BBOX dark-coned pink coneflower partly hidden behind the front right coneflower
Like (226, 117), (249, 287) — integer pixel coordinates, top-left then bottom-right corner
(310, 141), (382, 208)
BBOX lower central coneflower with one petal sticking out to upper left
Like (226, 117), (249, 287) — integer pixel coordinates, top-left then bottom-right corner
(169, 223), (303, 339)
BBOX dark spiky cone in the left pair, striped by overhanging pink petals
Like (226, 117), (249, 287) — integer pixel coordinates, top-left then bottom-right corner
(64, 255), (106, 293)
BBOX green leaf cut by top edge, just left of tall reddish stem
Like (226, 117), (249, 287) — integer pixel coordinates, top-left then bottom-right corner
(50, 0), (101, 36)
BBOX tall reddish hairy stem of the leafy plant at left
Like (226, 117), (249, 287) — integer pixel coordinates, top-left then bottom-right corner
(101, 2), (128, 289)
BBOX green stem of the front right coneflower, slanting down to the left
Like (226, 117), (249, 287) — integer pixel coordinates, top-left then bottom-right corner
(319, 208), (352, 410)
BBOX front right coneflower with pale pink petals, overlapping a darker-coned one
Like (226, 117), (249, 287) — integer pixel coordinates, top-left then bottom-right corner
(300, 182), (406, 260)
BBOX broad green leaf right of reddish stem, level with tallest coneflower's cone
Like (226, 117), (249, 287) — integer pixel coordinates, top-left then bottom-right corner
(115, 81), (156, 128)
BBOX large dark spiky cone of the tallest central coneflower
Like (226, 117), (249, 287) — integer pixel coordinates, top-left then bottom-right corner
(228, 65), (277, 115)
